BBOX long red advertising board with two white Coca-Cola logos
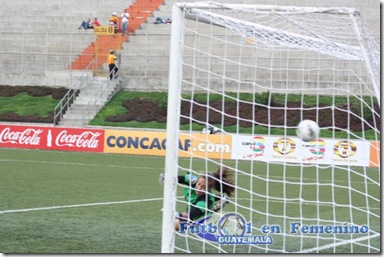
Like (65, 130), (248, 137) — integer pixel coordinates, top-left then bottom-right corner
(0, 125), (104, 152)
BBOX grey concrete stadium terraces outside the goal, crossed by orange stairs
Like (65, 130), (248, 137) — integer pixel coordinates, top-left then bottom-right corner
(0, 0), (380, 90)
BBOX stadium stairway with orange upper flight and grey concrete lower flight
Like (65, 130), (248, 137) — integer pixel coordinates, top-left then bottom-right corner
(58, 0), (164, 127)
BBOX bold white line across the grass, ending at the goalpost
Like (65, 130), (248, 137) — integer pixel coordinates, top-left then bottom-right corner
(0, 198), (163, 214)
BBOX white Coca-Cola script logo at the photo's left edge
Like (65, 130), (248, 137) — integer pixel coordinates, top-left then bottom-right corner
(0, 128), (43, 145)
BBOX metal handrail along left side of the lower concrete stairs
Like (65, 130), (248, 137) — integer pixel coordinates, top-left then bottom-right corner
(53, 59), (95, 125)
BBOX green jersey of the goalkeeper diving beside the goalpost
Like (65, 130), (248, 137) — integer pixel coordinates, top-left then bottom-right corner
(178, 174), (215, 220)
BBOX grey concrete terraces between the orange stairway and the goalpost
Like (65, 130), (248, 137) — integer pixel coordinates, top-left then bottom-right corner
(120, 0), (201, 90)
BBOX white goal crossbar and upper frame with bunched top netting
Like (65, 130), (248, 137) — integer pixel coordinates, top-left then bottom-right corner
(182, 2), (380, 102)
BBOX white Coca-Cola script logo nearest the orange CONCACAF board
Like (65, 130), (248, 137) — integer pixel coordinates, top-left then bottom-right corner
(55, 130), (101, 148)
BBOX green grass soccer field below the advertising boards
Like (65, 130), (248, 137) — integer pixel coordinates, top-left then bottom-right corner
(0, 148), (380, 254)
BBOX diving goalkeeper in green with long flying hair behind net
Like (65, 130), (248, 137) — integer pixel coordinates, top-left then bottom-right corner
(175, 167), (235, 231)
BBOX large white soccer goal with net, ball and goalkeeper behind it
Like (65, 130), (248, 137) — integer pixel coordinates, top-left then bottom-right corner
(162, 2), (381, 253)
